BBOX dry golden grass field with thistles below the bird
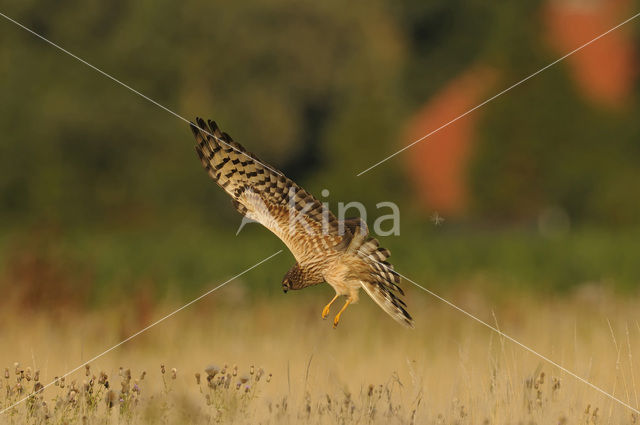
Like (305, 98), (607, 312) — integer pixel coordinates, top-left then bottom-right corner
(0, 282), (640, 424)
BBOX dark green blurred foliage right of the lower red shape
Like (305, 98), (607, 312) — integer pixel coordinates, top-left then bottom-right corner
(469, 52), (640, 227)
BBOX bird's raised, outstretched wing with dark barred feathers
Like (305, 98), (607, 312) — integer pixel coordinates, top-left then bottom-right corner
(191, 118), (351, 263)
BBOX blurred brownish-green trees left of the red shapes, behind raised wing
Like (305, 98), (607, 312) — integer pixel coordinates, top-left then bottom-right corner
(0, 0), (404, 223)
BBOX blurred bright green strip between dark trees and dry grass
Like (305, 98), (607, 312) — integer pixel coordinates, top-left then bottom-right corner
(0, 223), (640, 308)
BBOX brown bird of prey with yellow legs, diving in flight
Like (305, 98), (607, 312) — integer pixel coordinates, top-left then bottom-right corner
(190, 118), (413, 328)
